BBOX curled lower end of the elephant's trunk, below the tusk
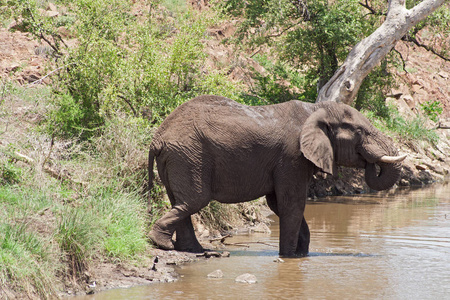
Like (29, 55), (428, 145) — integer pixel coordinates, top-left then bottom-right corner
(365, 162), (402, 191)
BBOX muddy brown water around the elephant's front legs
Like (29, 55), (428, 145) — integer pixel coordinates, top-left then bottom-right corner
(80, 184), (450, 300)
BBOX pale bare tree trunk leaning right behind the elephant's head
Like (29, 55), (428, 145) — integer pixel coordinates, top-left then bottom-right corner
(316, 0), (446, 104)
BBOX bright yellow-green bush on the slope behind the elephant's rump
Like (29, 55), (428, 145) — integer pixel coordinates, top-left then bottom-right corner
(48, 0), (239, 136)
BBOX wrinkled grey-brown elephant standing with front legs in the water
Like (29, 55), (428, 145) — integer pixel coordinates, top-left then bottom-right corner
(149, 96), (401, 257)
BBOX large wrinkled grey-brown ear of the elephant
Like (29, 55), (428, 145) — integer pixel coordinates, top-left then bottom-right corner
(300, 108), (336, 175)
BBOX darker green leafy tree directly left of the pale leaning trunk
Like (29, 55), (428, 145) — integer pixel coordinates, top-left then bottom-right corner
(218, 0), (373, 99)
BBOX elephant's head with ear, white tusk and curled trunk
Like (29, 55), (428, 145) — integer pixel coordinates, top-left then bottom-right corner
(300, 102), (406, 191)
